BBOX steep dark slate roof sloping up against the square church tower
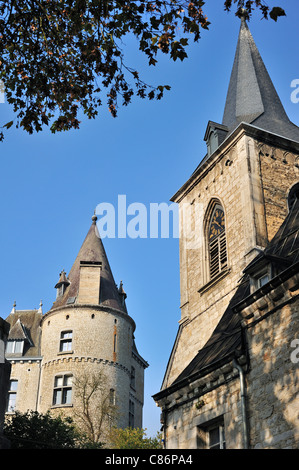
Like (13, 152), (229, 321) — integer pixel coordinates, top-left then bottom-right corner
(155, 198), (299, 398)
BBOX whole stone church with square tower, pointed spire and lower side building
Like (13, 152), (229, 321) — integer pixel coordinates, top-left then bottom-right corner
(154, 18), (299, 449)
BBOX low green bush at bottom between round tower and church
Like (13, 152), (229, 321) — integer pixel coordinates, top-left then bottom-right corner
(110, 428), (162, 449)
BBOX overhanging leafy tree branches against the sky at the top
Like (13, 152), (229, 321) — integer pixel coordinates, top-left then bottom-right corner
(0, 0), (285, 140)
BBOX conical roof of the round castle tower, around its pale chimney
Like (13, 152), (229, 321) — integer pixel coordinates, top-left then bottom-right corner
(52, 216), (126, 313)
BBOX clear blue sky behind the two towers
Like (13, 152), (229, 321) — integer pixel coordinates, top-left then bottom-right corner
(0, 0), (299, 435)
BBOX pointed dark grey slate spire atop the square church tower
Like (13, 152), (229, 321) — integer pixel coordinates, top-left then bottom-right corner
(222, 18), (299, 142)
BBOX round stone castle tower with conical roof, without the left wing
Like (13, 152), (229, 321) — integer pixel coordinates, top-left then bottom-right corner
(39, 216), (148, 438)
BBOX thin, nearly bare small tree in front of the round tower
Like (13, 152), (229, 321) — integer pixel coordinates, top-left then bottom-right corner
(73, 370), (117, 447)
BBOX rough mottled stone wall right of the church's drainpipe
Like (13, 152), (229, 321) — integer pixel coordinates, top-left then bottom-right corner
(248, 300), (299, 449)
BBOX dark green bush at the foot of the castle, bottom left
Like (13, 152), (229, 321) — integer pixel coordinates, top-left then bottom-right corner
(4, 411), (78, 449)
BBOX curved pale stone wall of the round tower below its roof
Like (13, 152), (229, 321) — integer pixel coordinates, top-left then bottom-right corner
(39, 306), (143, 434)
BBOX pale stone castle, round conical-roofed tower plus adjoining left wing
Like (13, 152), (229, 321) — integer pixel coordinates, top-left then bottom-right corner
(6, 212), (148, 440)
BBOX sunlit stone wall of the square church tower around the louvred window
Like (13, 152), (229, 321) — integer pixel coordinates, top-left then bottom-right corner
(165, 131), (265, 385)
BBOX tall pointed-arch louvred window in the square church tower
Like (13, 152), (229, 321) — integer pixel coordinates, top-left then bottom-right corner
(208, 204), (227, 279)
